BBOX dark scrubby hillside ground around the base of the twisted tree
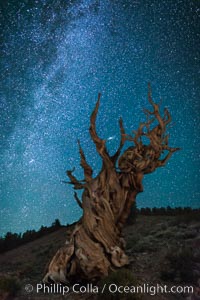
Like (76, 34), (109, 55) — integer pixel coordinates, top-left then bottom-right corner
(0, 215), (200, 300)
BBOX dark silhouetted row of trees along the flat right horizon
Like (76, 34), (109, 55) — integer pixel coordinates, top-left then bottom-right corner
(136, 206), (200, 216)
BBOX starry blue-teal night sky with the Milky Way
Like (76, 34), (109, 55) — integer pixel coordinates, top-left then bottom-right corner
(0, 0), (200, 235)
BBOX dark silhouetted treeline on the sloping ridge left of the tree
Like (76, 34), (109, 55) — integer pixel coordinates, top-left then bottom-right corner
(0, 219), (63, 253)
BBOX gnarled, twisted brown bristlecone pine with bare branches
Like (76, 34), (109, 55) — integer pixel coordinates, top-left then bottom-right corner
(43, 84), (179, 282)
